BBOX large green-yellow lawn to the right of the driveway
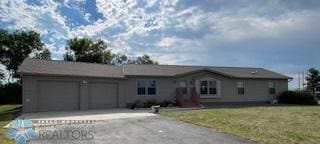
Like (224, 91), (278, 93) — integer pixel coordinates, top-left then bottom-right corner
(162, 106), (320, 144)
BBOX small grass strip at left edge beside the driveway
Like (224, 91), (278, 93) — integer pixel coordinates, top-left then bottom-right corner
(0, 105), (21, 144)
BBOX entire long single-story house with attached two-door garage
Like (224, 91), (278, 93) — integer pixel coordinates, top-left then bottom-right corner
(18, 59), (290, 112)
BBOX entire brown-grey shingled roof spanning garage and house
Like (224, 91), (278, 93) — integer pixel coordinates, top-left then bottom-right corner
(18, 59), (290, 79)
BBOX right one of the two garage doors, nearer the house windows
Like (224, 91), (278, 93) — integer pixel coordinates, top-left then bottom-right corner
(89, 83), (118, 109)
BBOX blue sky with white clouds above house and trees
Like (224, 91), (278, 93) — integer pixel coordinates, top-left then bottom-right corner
(0, 0), (320, 88)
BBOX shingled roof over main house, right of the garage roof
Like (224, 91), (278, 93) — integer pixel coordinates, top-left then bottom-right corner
(124, 65), (290, 79)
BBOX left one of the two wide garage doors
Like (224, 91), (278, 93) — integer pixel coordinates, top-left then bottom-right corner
(38, 81), (80, 111)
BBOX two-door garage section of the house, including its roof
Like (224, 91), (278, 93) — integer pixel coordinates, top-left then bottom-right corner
(18, 58), (125, 113)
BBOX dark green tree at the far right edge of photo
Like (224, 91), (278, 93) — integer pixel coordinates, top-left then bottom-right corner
(306, 68), (320, 94)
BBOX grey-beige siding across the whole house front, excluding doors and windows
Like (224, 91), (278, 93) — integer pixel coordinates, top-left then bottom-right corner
(22, 72), (288, 112)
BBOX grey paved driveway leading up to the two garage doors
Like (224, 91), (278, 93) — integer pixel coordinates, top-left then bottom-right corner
(24, 111), (250, 144)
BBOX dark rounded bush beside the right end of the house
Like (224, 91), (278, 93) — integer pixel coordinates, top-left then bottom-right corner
(278, 91), (318, 105)
